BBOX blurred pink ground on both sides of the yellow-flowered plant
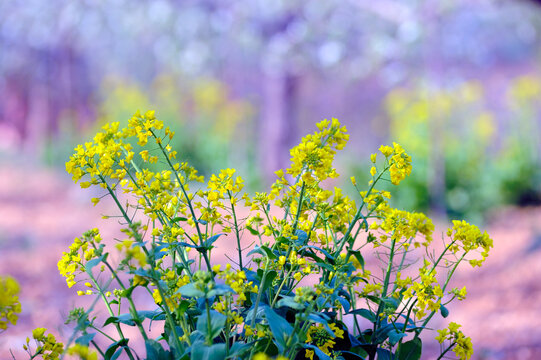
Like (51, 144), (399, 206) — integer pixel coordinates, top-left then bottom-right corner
(0, 165), (541, 360)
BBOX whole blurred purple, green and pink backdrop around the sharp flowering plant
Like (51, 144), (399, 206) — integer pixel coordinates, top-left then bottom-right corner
(0, 0), (541, 359)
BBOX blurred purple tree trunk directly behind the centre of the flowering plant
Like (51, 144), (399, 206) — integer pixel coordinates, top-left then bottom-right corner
(258, 71), (298, 183)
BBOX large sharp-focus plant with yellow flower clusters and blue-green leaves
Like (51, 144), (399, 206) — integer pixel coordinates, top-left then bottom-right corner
(25, 111), (492, 360)
